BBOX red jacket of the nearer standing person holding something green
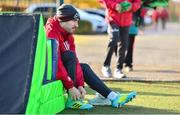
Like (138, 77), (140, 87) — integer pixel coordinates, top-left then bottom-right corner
(98, 0), (141, 27)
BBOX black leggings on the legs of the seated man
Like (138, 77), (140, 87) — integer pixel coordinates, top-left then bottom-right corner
(61, 51), (111, 97)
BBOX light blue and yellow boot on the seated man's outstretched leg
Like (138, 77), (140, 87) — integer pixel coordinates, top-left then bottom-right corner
(111, 92), (137, 108)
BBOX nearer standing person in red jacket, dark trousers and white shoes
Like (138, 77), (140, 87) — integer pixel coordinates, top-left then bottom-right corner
(98, 0), (141, 79)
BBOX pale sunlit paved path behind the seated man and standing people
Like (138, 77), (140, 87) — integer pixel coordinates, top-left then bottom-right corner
(75, 23), (180, 82)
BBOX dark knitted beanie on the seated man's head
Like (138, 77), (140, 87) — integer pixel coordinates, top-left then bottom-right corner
(56, 4), (80, 22)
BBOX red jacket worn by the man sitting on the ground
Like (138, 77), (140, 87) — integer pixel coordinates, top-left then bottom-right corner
(45, 17), (84, 89)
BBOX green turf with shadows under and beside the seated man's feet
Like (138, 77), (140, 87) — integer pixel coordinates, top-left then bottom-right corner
(60, 82), (180, 114)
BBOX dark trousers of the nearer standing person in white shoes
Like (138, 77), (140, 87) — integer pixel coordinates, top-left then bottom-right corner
(104, 23), (129, 69)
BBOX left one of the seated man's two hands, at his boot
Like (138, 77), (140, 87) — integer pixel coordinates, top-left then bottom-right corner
(68, 87), (81, 100)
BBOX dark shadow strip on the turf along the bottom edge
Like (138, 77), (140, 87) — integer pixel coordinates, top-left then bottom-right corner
(59, 105), (179, 114)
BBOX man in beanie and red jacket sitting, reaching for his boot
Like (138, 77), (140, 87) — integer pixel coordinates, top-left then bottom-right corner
(45, 4), (136, 109)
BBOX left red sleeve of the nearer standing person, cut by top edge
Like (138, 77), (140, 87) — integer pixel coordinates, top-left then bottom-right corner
(98, 0), (118, 10)
